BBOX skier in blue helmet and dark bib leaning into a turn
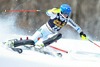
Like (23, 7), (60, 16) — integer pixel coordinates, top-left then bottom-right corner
(8, 4), (86, 48)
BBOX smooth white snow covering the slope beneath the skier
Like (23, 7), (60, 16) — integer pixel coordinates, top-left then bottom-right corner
(0, 35), (100, 67)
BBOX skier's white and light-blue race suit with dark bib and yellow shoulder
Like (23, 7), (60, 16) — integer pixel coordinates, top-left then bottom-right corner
(31, 8), (82, 43)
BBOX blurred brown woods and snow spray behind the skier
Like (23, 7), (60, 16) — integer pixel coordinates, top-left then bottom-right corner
(0, 0), (100, 40)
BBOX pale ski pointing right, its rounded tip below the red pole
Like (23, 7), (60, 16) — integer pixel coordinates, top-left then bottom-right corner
(24, 45), (63, 57)
